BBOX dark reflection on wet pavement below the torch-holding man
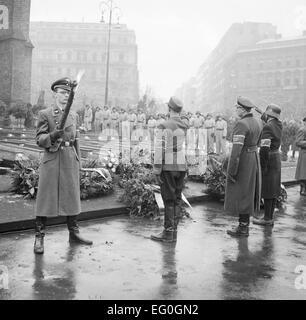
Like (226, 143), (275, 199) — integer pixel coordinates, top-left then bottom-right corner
(32, 246), (77, 300)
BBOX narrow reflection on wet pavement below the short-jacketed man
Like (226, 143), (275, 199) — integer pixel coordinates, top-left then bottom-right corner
(157, 242), (178, 299)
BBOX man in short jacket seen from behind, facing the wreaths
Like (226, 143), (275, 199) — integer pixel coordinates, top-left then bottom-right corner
(151, 97), (188, 242)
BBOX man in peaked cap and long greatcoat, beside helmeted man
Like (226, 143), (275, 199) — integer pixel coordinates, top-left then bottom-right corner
(224, 97), (262, 237)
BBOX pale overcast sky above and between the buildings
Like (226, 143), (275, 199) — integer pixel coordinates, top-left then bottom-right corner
(31, 0), (306, 99)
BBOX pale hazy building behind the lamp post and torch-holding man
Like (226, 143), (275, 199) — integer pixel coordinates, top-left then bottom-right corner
(30, 22), (139, 107)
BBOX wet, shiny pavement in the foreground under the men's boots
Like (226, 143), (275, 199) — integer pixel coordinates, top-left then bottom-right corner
(0, 187), (306, 300)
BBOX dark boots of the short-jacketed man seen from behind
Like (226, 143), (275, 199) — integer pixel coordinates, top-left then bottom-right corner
(151, 204), (177, 242)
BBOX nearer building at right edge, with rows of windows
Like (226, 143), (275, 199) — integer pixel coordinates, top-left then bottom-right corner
(224, 33), (306, 118)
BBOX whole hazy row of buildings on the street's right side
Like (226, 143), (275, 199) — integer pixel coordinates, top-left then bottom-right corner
(176, 22), (306, 116)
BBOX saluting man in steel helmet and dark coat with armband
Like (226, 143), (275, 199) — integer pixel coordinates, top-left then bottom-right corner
(253, 104), (283, 226)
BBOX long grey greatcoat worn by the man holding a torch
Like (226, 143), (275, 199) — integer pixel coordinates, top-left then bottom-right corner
(35, 106), (81, 217)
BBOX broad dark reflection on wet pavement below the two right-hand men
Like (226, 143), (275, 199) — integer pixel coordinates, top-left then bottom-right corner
(222, 229), (275, 299)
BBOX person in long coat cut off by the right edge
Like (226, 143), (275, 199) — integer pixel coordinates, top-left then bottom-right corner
(295, 117), (306, 196)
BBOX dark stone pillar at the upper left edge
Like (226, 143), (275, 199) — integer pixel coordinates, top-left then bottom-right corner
(0, 0), (33, 105)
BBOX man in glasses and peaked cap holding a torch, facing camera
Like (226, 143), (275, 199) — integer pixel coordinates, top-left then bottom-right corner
(34, 78), (92, 254)
